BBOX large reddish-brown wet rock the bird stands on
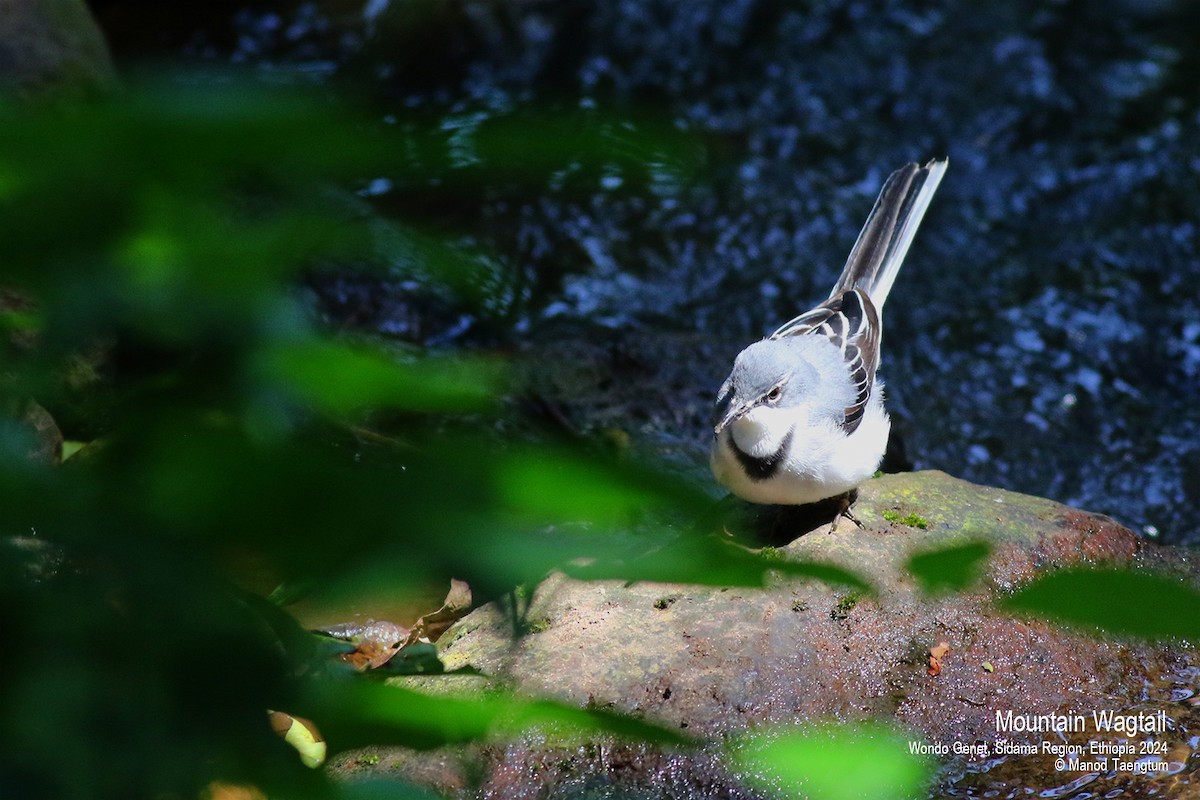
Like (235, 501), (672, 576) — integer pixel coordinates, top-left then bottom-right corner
(336, 473), (1200, 796)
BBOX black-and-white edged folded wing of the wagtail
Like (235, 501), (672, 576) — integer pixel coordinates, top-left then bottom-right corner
(769, 289), (880, 434)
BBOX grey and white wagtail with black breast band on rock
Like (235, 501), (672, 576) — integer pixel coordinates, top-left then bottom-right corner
(709, 158), (947, 505)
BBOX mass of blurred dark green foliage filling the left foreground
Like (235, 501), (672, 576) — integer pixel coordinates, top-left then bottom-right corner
(0, 80), (883, 799)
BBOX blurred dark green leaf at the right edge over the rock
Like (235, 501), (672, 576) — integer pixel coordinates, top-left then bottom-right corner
(1001, 569), (1200, 640)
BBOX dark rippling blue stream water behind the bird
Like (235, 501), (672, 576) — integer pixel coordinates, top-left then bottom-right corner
(95, 0), (1200, 545)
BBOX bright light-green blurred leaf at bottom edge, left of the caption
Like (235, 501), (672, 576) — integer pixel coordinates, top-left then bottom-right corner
(731, 724), (932, 800)
